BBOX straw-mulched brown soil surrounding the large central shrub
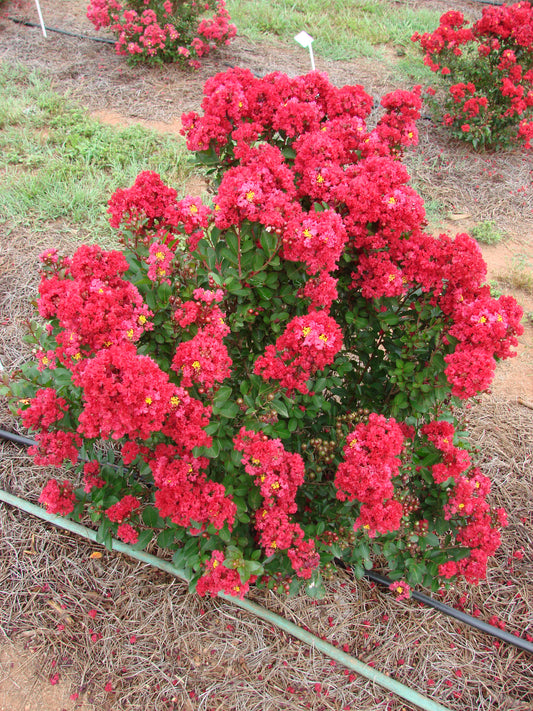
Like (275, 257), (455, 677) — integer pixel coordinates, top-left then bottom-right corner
(0, 0), (533, 711)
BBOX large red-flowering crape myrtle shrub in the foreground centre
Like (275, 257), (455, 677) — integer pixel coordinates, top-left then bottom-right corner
(11, 69), (523, 596)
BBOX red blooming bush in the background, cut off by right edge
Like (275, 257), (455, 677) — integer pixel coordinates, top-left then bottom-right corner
(412, 2), (533, 148)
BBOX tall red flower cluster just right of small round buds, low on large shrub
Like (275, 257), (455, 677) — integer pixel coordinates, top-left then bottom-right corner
(335, 413), (404, 537)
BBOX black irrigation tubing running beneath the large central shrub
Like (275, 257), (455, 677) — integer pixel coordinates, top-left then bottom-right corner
(0, 429), (533, 654)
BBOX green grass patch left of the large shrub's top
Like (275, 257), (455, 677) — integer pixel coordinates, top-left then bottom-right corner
(0, 65), (192, 234)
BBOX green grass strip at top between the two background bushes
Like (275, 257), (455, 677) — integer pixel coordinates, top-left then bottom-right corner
(227, 0), (440, 65)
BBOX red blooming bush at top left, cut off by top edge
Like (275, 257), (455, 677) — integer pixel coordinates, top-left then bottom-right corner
(87, 0), (236, 69)
